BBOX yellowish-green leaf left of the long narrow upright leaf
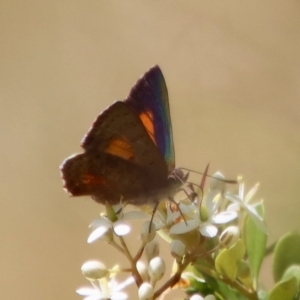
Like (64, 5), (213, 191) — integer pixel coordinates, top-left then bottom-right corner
(215, 240), (246, 281)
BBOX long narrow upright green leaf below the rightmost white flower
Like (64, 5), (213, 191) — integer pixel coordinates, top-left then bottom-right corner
(244, 203), (267, 282)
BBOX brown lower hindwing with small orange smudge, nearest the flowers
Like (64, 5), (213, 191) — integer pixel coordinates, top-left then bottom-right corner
(61, 153), (169, 204)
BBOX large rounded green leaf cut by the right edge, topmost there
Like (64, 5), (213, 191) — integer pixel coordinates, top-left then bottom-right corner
(273, 232), (300, 282)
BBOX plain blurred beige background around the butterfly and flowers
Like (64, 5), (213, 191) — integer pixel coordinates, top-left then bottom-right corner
(0, 0), (300, 300)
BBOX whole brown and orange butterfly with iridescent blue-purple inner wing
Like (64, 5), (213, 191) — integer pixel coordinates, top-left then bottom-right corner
(60, 66), (187, 205)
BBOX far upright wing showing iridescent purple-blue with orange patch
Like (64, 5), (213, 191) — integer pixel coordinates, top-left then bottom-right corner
(125, 66), (175, 172)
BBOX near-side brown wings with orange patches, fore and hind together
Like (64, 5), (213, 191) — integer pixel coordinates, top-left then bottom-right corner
(61, 101), (168, 203)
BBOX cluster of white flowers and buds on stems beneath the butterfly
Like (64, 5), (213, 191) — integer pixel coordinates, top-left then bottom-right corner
(77, 173), (266, 300)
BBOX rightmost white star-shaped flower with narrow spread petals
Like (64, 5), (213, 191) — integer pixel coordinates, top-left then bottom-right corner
(225, 183), (267, 233)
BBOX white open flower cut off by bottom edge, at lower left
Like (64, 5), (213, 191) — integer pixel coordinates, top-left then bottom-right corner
(76, 277), (134, 300)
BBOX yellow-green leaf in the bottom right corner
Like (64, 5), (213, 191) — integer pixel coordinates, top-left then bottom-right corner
(269, 276), (298, 300)
